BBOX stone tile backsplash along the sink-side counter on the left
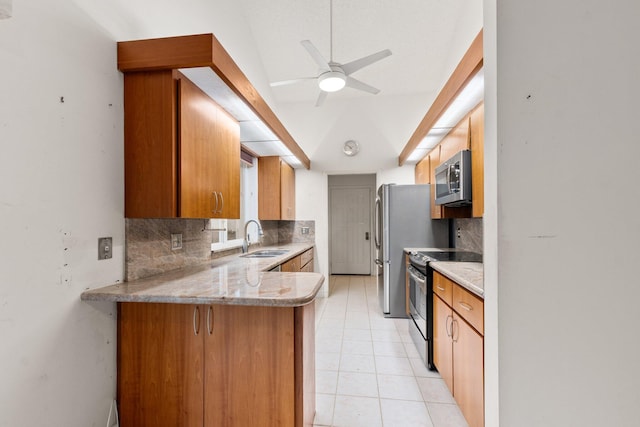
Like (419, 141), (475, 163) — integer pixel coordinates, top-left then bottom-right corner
(125, 218), (315, 281)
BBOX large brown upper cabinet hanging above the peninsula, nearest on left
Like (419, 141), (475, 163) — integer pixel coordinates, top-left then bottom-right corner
(124, 70), (240, 218)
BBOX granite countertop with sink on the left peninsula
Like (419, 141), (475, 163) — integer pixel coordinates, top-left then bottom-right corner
(81, 243), (324, 307)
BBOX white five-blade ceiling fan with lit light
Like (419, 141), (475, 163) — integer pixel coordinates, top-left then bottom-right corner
(271, 0), (391, 107)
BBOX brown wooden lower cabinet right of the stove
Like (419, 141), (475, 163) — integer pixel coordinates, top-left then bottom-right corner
(433, 272), (484, 427)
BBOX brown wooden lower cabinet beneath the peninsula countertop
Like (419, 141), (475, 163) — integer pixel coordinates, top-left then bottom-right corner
(117, 302), (315, 427)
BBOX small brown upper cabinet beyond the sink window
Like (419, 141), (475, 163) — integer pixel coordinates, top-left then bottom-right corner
(258, 156), (296, 220)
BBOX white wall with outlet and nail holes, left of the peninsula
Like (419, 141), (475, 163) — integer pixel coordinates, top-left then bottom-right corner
(0, 0), (124, 426)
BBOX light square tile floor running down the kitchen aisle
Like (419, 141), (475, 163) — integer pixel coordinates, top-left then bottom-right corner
(314, 276), (467, 427)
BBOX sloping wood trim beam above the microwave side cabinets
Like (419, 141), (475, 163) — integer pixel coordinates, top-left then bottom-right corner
(398, 30), (483, 166)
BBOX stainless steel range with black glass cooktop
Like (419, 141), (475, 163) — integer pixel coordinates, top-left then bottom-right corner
(408, 249), (482, 370)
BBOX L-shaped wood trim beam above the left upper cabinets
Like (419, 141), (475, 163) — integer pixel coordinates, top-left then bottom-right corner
(118, 34), (311, 169)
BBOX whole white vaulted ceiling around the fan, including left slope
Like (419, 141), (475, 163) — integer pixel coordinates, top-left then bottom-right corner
(72, 0), (482, 173)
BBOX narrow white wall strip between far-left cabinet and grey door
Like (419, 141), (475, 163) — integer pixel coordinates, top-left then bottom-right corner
(296, 169), (329, 296)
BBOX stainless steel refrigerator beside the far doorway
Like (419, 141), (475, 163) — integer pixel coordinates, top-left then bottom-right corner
(374, 184), (449, 317)
